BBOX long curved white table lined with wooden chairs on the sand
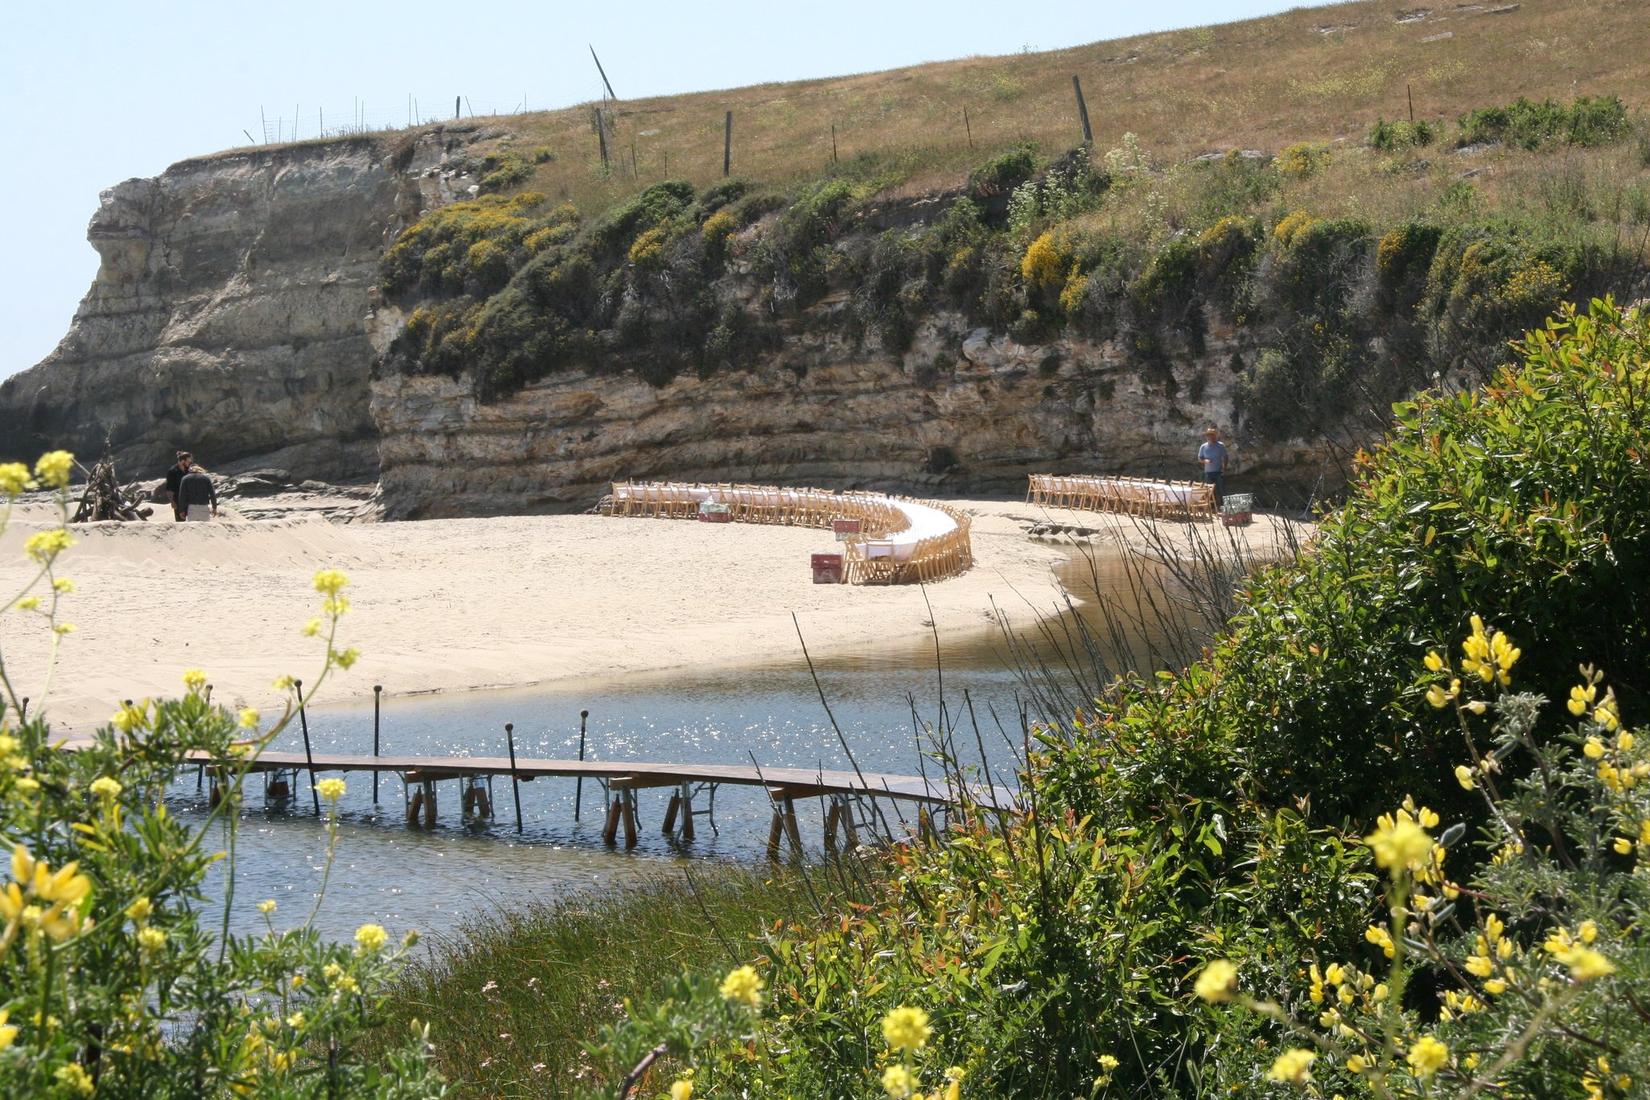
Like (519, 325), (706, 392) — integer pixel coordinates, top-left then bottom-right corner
(604, 482), (974, 584)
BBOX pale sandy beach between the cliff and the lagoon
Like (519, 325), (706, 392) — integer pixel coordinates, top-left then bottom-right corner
(0, 501), (1300, 734)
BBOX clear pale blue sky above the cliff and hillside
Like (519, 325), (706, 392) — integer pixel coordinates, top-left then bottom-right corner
(0, 0), (1310, 378)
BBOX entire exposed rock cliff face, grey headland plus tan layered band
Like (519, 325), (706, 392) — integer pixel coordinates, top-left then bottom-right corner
(0, 127), (1327, 518)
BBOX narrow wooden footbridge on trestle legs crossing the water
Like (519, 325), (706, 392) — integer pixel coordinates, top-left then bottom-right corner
(190, 739), (1020, 858)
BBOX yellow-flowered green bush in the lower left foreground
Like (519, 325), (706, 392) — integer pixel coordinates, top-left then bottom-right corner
(0, 452), (444, 1100)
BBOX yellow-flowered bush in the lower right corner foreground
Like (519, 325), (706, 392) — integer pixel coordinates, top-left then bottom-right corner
(1193, 615), (1650, 1098)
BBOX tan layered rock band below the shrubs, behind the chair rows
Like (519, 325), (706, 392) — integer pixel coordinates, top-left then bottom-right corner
(370, 312), (1328, 518)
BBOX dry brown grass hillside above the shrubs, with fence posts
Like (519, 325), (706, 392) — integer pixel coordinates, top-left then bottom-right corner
(311, 0), (1650, 213)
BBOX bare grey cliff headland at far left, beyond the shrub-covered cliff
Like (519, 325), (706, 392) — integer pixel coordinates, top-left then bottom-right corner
(0, 130), (481, 478)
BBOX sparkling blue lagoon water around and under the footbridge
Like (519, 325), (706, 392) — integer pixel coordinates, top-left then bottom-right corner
(183, 557), (1214, 938)
